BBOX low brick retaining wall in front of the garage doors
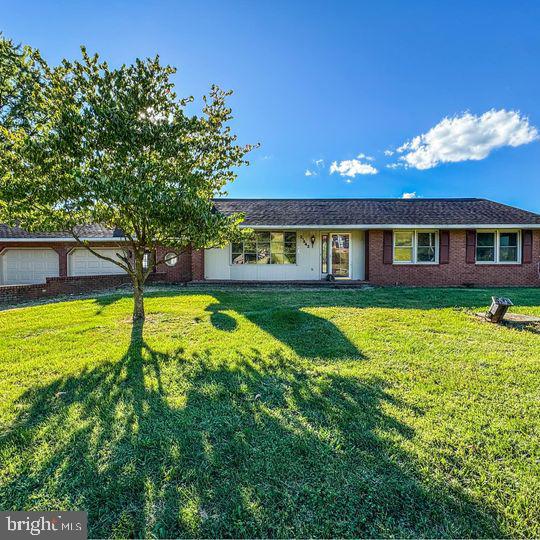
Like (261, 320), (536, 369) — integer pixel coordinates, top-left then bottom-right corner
(0, 273), (166, 304)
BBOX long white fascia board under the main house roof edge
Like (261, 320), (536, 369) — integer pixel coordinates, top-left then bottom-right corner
(240, 223), (540, 231)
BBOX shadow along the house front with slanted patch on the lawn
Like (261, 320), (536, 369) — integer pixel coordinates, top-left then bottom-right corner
(90, 287), (540, 360)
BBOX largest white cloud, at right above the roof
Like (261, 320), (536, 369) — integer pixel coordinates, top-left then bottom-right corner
(397, 109), (539, 169)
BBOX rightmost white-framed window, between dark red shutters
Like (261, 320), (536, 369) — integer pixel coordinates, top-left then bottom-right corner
(476, 231), (521, 264)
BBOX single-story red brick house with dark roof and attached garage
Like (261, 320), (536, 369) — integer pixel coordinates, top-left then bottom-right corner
(0, 198), (540, 300)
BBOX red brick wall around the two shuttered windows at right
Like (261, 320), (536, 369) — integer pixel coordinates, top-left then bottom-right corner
(367, 230), (540, 287)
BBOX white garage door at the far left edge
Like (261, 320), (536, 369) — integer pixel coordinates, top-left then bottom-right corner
(0, 249), (58, 285)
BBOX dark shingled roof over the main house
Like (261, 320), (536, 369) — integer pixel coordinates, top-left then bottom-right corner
(215, 199), (540, 226)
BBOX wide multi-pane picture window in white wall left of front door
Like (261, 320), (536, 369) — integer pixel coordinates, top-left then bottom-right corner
(231, 231), (296, 264)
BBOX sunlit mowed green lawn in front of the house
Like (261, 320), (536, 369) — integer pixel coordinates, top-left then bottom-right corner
(0, 288), (540, 537)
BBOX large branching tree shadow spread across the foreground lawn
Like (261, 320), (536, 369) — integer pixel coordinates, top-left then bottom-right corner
(0, 325), (501, 537)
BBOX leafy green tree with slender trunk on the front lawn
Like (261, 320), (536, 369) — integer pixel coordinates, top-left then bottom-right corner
(0, 43), (253, 321)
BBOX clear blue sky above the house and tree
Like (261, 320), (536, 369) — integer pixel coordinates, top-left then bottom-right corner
(4, 0), (540, 212)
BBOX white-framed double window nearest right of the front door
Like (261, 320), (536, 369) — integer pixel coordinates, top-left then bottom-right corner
(394, 230), (439, 264)
